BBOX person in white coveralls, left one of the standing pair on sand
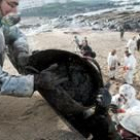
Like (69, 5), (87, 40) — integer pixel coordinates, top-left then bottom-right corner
(107, 49), (120, 80)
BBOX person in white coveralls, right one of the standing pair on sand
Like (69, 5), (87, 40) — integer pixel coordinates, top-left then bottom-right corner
(124, 50), (136, 84)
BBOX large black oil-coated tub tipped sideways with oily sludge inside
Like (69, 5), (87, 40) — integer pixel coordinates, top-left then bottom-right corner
(24, 49), (111, 140)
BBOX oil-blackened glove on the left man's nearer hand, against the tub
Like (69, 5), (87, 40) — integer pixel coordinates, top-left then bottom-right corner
(34, 65), (67, 91)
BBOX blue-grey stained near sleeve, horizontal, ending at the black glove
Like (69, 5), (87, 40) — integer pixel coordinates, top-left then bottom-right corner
(0, 66), (34, 97)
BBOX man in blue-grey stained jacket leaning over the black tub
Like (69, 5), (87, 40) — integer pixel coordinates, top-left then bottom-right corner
(0, 0), (49, 97)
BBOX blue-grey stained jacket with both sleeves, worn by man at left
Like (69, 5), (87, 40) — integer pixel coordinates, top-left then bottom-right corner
(0, 14), (34, 97)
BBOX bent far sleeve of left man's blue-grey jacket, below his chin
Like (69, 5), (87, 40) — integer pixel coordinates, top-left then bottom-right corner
(3, 26), (30, 69)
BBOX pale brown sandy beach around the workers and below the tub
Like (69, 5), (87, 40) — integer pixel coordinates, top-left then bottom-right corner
(0, 29), (140, 140)
